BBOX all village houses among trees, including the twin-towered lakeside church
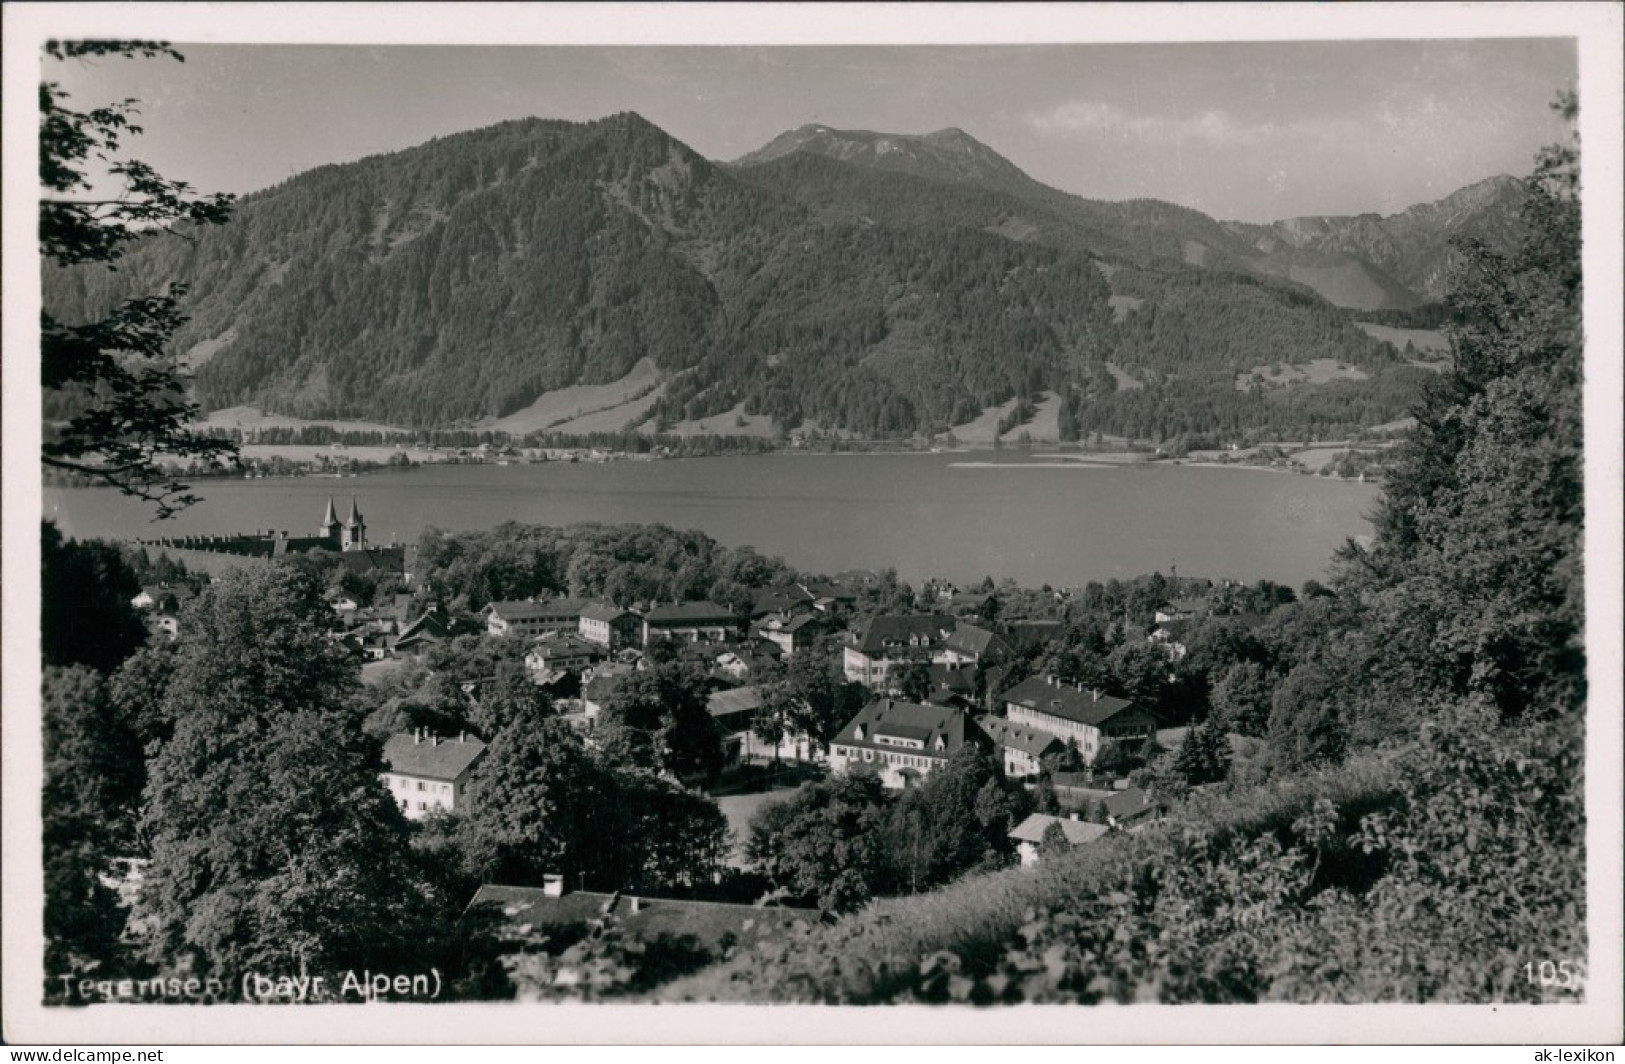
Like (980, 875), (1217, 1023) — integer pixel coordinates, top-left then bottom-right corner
(135, 500), (1204, 864)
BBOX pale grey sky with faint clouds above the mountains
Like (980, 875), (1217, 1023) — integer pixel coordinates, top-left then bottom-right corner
(42, 37), (1578, 221)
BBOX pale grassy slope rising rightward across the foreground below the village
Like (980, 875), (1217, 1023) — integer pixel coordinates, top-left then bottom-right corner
(655, 757), (1398, 1004)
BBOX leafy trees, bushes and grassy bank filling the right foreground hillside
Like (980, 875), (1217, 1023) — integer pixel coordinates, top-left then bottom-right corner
(650, 104), (1586, 1004)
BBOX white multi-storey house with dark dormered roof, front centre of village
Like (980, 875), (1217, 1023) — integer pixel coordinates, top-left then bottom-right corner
(829, 699), (977, 791)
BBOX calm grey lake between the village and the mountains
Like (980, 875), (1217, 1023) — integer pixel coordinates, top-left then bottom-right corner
(44, 452), (1378, 586)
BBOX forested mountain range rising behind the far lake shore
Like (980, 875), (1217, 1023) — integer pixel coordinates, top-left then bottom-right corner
(46, 114), (1523, 439)
